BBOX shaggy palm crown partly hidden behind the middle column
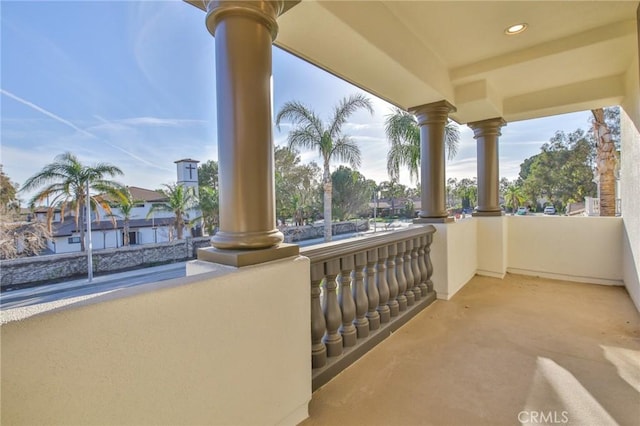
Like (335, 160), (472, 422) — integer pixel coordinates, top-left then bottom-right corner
(384, 108), (460, 180)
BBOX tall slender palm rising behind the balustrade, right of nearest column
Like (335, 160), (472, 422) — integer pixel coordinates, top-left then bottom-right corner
(276, 94), (373, 241)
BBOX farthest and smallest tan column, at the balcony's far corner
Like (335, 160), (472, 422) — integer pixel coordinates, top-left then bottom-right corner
(468, 117), (507, 216)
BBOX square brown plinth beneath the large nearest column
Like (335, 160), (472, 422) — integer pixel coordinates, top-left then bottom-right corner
(198, 243), (300, 268)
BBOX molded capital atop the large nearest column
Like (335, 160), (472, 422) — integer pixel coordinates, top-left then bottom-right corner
(206, 0), (291, 41)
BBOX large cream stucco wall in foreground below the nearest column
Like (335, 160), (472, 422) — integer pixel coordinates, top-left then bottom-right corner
(1, 257), (311, 425)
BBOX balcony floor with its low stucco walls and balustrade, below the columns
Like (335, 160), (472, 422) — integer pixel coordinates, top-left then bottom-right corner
(2, 216), (640, 424)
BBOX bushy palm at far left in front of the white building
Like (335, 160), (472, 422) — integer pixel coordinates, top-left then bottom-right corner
(21, 152), (123, 251)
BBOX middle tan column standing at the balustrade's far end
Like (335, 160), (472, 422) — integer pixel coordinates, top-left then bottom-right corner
(410, 101), (456, 222)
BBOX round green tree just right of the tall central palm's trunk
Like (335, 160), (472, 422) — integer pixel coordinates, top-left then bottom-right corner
(331, 166), (373, 220)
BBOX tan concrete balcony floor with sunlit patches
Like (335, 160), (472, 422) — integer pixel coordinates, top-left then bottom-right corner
(302, 274), (640, 426)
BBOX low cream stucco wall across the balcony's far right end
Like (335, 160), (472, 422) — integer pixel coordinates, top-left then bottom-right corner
(505, 216), (623, 285)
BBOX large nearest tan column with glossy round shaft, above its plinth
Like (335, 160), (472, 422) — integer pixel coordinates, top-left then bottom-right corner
(206, 0), (284, 249)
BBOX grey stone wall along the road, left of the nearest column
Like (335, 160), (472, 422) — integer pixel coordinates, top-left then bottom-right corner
(0, 237), (210, 290)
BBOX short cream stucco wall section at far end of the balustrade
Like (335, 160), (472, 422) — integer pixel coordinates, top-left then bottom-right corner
(431, 218), (478, 300)
